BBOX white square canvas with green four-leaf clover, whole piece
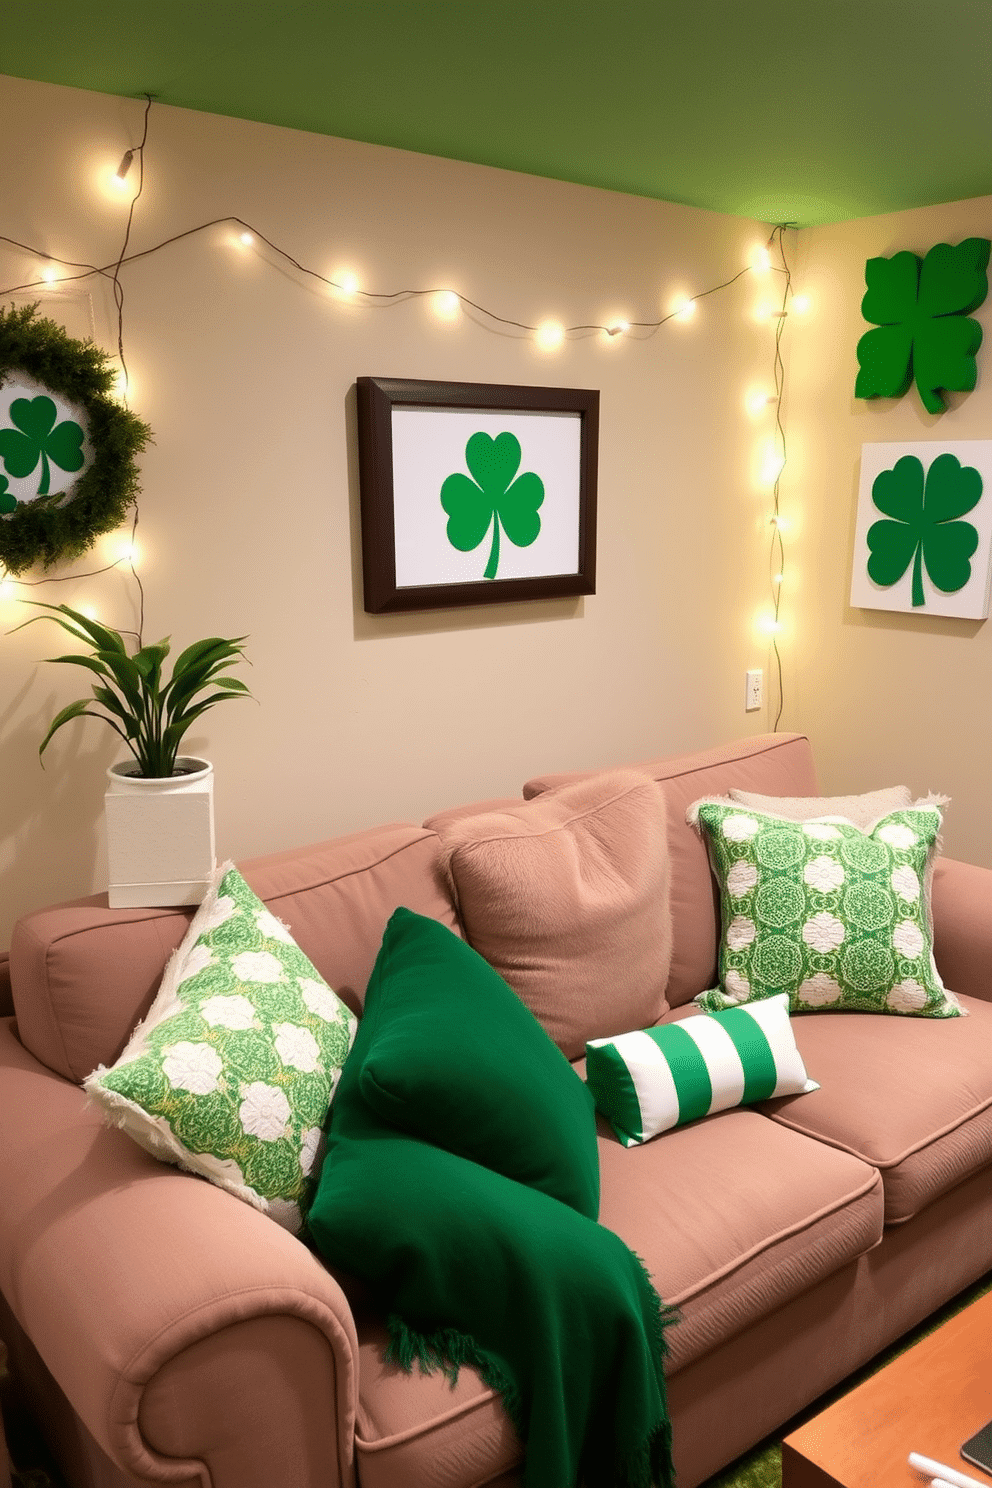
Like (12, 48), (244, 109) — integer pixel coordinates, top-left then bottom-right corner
(851, 439), (992, 620)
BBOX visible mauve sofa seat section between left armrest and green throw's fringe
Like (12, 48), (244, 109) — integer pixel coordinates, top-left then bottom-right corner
(355, 1314), (524, 1488)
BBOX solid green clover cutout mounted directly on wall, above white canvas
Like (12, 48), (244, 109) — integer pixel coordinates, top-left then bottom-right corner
(854, 238), (991, 414)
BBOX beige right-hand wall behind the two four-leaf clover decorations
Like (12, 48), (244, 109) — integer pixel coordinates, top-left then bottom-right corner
(782, 196), (992, 863)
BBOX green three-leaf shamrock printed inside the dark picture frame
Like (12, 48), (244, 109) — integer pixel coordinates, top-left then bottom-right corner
(440, 432), (544, 579)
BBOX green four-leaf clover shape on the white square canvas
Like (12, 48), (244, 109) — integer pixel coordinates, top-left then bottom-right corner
(869, 454), (982, 606)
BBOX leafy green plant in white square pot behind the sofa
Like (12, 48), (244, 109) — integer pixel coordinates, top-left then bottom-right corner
(16, 601), (251, 909)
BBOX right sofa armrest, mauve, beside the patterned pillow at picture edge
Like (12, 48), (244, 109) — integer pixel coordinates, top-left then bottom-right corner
(931, 857), (992, 1001)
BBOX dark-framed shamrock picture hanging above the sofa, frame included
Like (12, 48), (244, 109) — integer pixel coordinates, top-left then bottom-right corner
(357, 376), (599, 615)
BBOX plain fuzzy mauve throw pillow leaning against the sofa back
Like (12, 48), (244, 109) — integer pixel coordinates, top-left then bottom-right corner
(439, 771), (671, 1059)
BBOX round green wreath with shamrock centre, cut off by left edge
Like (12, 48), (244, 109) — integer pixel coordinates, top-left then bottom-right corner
(0, 305), (152, 573)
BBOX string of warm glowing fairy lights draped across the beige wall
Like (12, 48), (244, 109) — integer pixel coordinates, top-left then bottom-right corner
(0, 92), (802, 729)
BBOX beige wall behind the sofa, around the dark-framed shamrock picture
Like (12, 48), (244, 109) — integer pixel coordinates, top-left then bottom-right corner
(0, 79), (791, 945)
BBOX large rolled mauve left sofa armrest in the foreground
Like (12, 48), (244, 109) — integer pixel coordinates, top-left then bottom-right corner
(0, 1021), (358, 1488)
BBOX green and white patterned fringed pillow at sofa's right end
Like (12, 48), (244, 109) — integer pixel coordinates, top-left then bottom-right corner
(687, 799), (964, 1018)
